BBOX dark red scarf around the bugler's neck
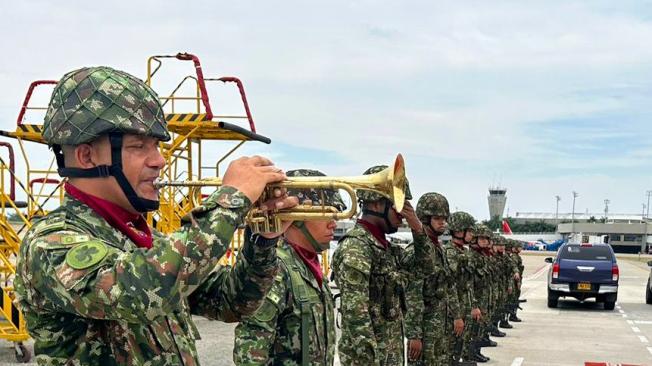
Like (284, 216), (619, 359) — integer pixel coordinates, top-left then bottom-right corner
(65, 183), (153, 249)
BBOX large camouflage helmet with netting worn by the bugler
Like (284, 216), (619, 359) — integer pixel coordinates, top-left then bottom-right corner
(43, 66), (170, 146)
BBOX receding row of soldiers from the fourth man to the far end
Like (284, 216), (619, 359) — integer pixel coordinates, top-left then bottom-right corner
(405, 199), (524, 365)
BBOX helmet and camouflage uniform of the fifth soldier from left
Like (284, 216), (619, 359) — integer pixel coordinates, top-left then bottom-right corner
(446, 211), (478, 361)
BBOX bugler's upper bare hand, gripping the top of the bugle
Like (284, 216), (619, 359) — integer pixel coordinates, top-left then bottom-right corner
(222, 156), (286, 202)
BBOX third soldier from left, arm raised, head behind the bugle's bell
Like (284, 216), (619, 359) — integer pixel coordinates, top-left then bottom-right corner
(332, 165), (434, 366)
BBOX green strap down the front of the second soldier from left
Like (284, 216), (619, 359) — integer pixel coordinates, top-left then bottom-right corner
(278, 248), (312, 366)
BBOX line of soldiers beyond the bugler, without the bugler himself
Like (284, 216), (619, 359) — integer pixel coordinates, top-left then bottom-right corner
(229, 182), (523, 366)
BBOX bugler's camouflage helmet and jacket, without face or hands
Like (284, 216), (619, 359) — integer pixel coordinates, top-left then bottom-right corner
(15, 67), (277, 365)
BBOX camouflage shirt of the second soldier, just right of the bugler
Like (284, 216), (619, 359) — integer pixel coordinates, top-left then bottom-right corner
(233, 240), (335, 366)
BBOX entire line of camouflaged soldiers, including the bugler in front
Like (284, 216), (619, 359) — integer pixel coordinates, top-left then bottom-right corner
(15, 67), (523, 366)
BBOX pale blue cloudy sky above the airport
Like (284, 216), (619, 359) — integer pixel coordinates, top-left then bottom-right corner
(0, 0), (652, 218)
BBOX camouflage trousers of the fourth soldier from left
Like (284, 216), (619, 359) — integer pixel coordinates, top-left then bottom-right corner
(408, 304), (453, 366)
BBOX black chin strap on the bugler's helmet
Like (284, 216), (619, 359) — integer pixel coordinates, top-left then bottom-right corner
(52, 133), (159, 213)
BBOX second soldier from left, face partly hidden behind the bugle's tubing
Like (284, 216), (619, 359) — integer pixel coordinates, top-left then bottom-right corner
(233, 169), (346, 366)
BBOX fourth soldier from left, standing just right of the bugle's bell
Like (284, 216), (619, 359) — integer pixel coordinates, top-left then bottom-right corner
(405, 192), (464, 366)
